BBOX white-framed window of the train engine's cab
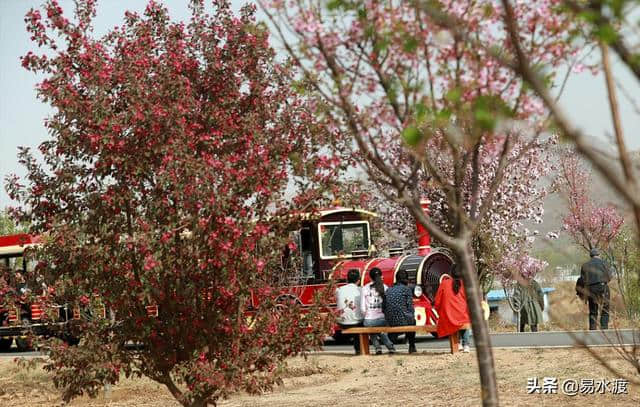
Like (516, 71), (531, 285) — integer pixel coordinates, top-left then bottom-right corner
(319, 221), (370, 259)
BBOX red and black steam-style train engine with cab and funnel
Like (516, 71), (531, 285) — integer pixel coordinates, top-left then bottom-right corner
(253, 201), (453, 334)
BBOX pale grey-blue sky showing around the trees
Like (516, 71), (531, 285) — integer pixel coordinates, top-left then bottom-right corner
(0, 0), (640, 208)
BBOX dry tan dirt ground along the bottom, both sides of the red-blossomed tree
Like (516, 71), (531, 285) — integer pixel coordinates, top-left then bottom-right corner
(0, 348), (640, 407)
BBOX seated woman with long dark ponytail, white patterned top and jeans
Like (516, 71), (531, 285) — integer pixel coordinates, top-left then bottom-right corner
(360, 267), (396, 355)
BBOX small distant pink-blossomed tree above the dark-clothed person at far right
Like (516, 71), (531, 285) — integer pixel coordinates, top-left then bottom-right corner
(558, 157), (624, 251)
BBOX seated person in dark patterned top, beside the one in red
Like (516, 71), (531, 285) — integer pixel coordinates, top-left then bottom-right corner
(384, 270), (417, 353)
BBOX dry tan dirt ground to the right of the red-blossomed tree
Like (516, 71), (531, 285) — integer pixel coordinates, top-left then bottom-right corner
(221, 349), (640, 407)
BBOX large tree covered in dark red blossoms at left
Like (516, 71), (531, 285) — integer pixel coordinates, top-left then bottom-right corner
(8, 0), (339, 406)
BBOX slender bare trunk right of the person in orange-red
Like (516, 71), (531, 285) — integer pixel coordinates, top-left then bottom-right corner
(455, 239), (498, 407)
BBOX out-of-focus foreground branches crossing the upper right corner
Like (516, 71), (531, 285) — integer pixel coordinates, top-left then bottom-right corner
(496, 0), (640, 382)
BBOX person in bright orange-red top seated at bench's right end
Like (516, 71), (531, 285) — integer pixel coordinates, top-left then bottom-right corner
(434, 264), (471, 353)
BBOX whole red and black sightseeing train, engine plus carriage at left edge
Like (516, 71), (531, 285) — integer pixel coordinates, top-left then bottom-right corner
(0, 201), (453, 344)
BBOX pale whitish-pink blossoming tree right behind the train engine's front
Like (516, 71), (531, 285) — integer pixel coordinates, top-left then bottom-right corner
(362, 138), (555, 289)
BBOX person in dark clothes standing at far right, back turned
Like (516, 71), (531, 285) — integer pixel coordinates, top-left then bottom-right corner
(576, 249), (611, 330)
